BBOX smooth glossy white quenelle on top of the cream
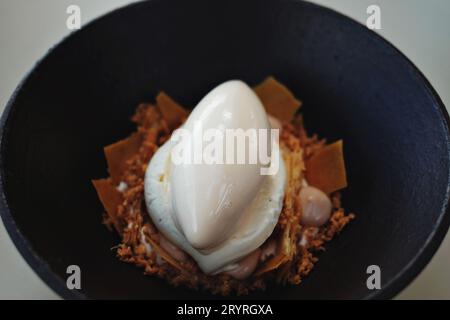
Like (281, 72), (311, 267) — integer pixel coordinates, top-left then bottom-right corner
(170, 81), (270, 250)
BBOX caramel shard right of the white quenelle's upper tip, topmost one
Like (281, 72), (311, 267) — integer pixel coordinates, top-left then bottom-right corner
(254, 77), (302, 122)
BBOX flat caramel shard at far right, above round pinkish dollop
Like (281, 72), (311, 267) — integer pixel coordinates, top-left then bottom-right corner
(305, 140), (347, 194)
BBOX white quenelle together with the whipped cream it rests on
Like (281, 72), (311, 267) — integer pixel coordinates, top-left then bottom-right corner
(145, 80), (286, 274)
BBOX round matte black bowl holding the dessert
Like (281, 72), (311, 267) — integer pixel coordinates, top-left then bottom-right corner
(0, 0), (450, 299)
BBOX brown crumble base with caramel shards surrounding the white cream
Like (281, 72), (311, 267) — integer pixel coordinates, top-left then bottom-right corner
(93, 78), (354, 295)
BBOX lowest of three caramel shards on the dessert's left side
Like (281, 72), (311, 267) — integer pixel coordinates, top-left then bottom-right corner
(92, 179), (123, 232)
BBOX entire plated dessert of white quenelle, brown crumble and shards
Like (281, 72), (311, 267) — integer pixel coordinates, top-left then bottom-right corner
(93, 77), (354, 295)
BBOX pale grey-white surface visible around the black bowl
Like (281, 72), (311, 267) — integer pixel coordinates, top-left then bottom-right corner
(0, 0), (450, 299)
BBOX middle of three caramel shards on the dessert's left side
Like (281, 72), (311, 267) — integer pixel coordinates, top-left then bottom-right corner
(104, 133), (142, 185)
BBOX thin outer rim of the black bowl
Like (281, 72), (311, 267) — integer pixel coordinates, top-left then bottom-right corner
(0, 0), (450, 299)
